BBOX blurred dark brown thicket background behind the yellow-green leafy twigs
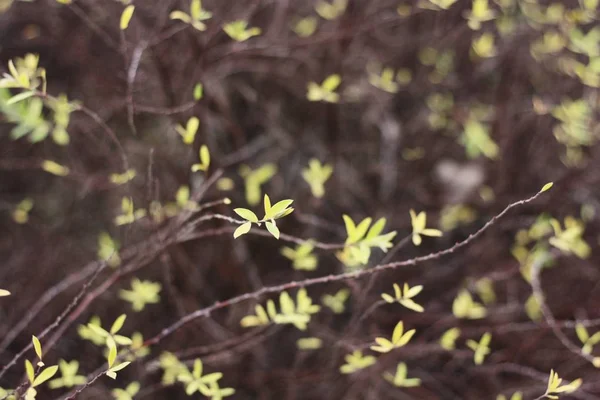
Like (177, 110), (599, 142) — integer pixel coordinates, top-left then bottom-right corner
(0, 0), (600, 400)
